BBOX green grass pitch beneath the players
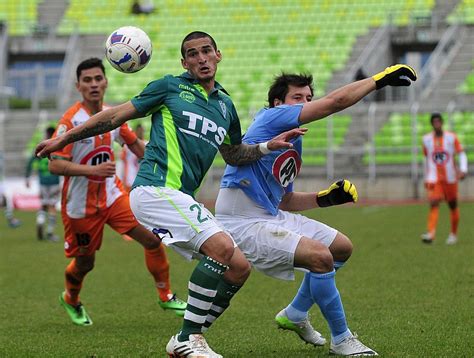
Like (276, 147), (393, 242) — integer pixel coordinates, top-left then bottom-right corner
(0, 204), (474, 357)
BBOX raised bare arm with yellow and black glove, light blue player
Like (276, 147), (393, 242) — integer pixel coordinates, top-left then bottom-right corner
(299, 65), (417, 124)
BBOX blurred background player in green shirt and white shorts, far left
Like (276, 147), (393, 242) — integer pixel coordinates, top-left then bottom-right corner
(25, 127), (61, 241)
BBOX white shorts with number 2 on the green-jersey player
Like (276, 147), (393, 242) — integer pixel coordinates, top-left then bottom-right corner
(130, 186), (230, 260)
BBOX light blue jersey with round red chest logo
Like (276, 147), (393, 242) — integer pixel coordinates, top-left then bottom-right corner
(221, 104), (303, 215)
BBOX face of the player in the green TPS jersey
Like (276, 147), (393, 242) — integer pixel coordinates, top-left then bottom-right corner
(181, 37), (222, 81)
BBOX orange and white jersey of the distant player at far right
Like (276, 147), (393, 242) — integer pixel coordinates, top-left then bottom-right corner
(423, 131), (463, 183)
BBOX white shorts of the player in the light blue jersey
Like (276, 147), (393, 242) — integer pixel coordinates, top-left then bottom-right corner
(216, 188), (337, 280)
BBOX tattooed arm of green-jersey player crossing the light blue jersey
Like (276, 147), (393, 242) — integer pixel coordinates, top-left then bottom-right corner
(219, 128), (308, 166)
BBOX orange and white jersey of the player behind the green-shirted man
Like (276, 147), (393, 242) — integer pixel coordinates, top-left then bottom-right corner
(52, 102), (137, 219)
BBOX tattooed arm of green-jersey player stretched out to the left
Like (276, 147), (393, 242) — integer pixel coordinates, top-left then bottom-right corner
(35, 101), (140, 157)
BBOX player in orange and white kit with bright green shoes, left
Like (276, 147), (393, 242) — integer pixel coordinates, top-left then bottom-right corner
(49, 58), (186, 326)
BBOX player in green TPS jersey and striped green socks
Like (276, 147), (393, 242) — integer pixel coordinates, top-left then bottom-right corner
(36, 31), (305, 358)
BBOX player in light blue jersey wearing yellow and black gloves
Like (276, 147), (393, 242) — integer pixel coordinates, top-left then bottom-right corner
(216, 65), (416, 356)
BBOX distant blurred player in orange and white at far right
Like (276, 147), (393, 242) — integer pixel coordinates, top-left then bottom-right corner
(421, 113), (467, 245)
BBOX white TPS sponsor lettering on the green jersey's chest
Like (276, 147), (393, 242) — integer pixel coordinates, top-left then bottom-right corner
(179, 111), (227, 148)
